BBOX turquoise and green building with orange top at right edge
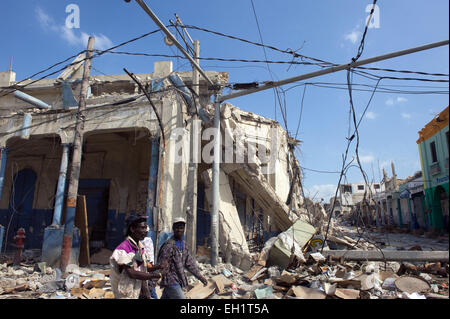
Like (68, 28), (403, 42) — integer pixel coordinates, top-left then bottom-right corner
(417, 106), (449, 232)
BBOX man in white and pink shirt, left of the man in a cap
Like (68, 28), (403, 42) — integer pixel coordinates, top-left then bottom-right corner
(110, 216), (167, 299)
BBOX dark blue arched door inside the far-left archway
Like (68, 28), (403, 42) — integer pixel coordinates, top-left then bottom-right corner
(6, 169), (37, 250)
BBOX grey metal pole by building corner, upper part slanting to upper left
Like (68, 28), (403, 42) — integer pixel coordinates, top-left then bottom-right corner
(125, 0), (221, 266)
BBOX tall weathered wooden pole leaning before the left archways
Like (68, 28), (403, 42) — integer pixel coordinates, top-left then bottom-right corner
(61, 37), (95, 273)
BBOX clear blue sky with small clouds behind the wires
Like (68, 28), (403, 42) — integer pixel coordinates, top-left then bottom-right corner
(0, 0), (449, 200)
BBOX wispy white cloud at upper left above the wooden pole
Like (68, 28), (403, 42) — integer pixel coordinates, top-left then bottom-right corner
(36, 7), (113, 50)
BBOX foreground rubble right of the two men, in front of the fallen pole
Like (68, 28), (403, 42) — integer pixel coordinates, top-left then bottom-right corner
(188, 253), (449, 299)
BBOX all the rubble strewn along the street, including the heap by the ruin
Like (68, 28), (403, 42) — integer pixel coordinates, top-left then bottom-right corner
(0, 222), (449, 299)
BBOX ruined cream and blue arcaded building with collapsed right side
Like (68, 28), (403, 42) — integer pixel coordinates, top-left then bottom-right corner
(0, 62), (312, 269)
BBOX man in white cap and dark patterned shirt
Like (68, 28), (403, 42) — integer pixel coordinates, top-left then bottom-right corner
(158, 217), (208, 299)
